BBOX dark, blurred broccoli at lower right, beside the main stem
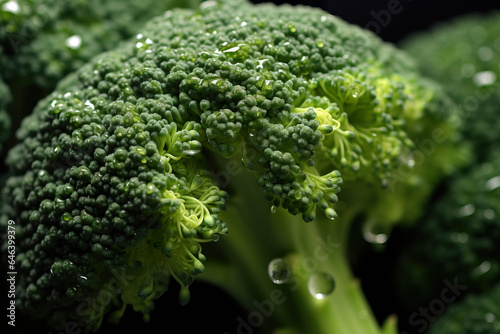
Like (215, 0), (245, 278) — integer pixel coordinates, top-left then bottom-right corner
(396, 153), (500, 309)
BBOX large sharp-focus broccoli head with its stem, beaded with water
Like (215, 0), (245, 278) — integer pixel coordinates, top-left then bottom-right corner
(2, 1), (461, 334)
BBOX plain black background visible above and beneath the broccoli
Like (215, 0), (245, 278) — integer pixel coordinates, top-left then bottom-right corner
(1, 0), (500, 334)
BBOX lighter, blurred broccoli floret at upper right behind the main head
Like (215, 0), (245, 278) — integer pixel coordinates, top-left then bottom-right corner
(402, 12), (500, 161)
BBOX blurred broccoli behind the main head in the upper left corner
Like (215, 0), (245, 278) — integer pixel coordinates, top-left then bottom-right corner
(0, 0), (200, 144)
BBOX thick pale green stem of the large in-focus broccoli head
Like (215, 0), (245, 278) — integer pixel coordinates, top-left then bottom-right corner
(199, 166), (390, 334)
